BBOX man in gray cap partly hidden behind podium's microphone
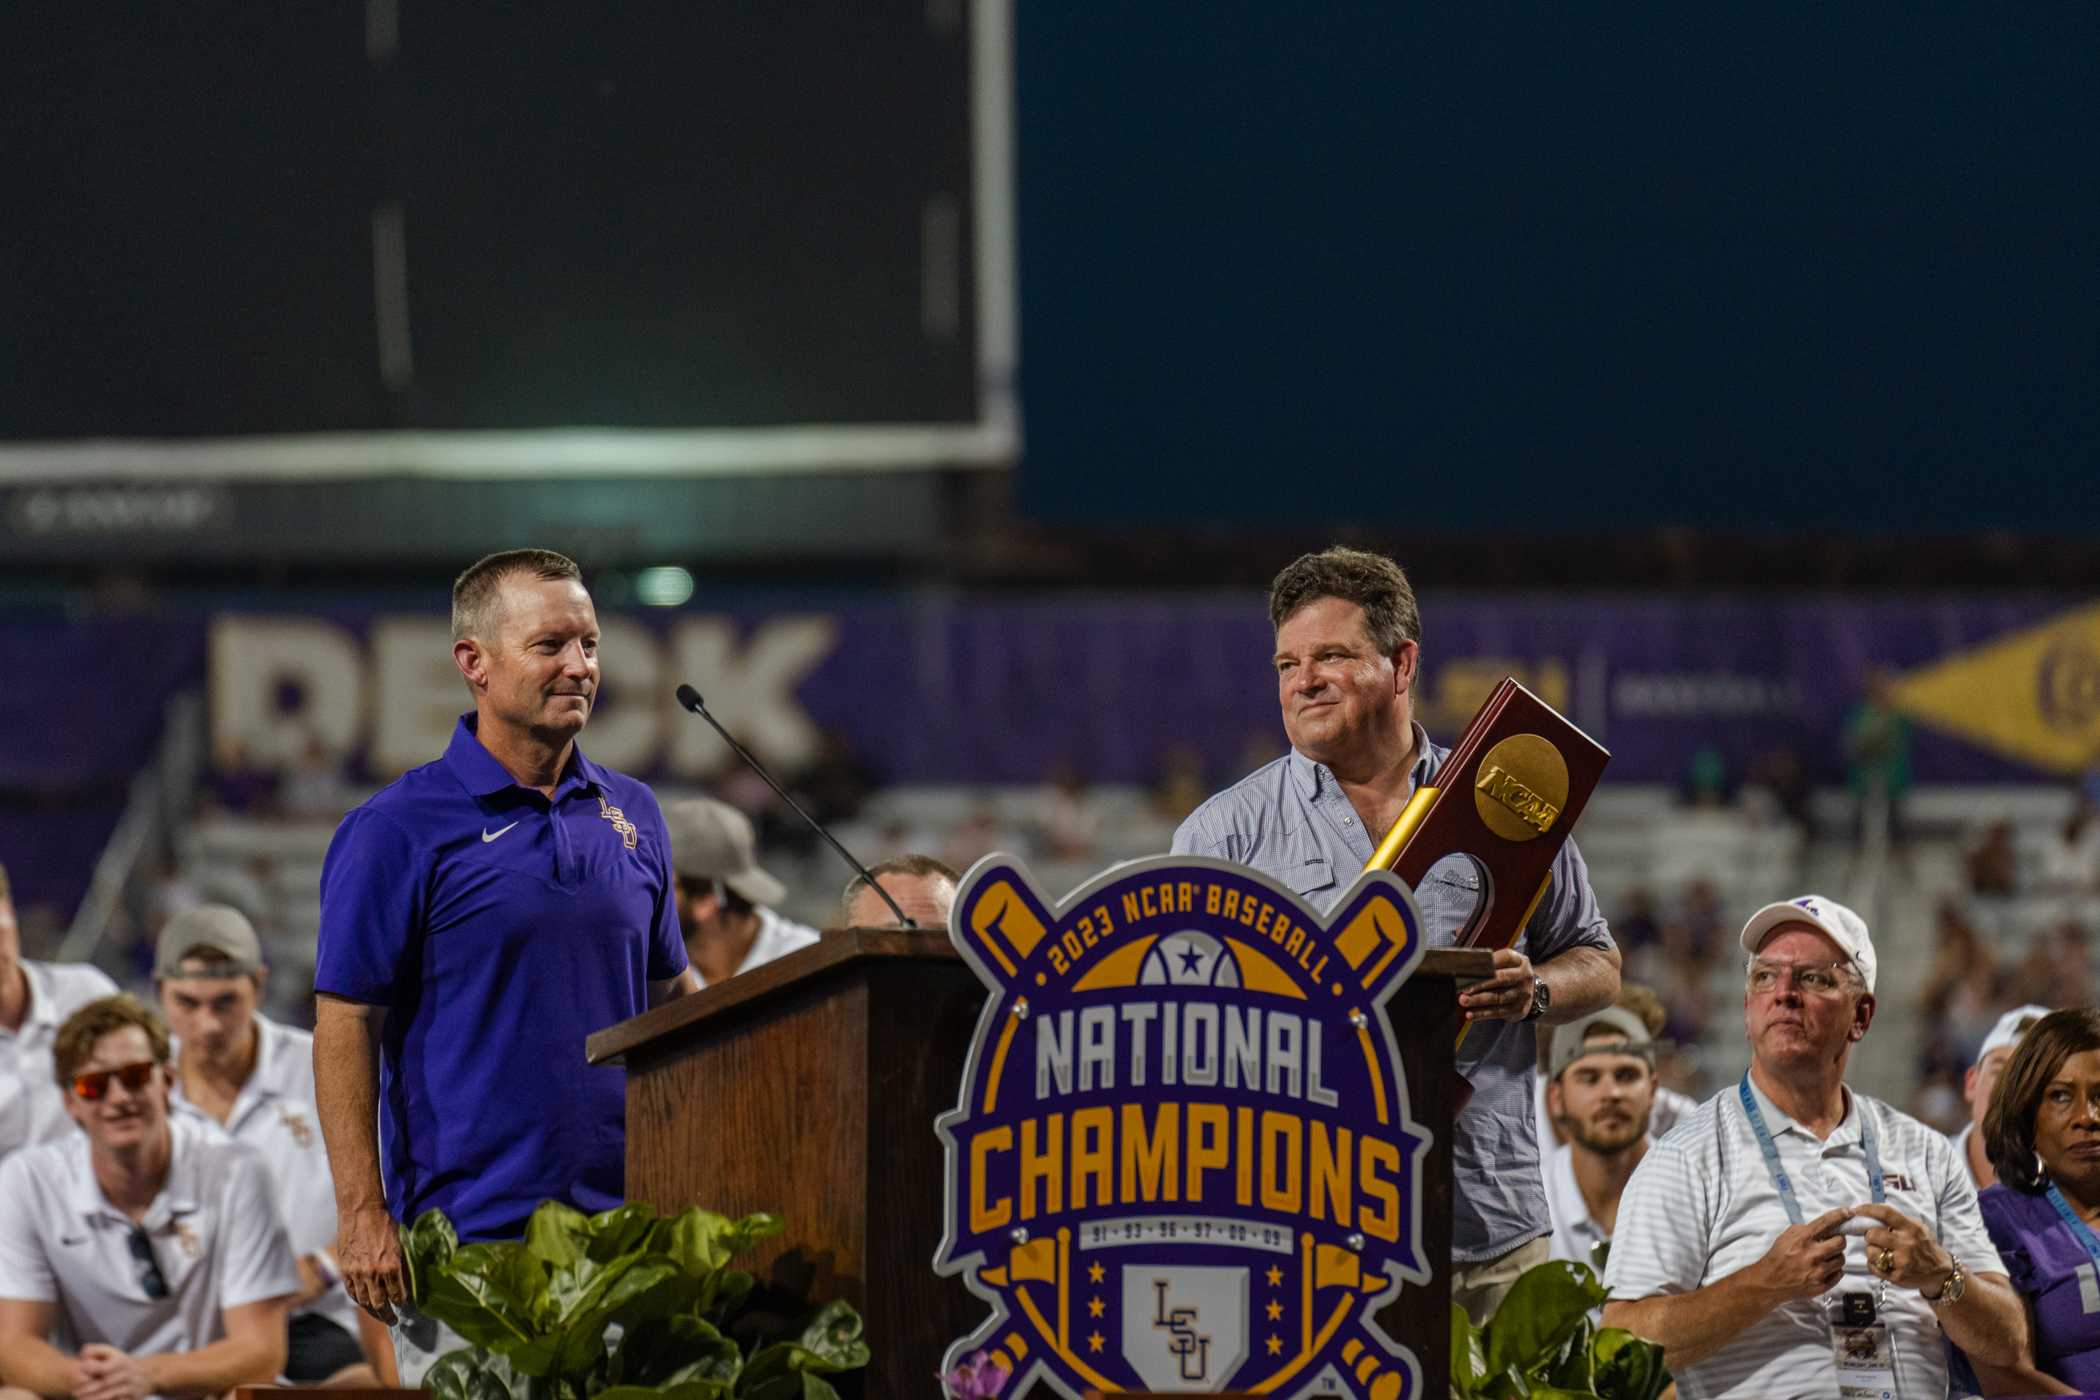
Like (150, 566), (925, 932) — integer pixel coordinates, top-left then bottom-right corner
(664, 798), (817, 987)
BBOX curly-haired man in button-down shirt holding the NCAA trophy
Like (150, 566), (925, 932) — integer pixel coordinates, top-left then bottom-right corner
(1174, 548), (1619, 1322)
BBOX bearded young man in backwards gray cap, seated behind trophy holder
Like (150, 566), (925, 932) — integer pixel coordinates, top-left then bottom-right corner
(1546, 1005), (1655, 1272)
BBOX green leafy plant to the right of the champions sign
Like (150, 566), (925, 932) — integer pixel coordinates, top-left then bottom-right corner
(1451, 1259), (1670, 1400)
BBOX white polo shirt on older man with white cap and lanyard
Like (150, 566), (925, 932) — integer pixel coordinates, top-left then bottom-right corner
(1604, 1083), (2006, 1400)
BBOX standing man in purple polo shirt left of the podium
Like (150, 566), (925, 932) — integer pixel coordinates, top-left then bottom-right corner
(313, 550), (697, 1360)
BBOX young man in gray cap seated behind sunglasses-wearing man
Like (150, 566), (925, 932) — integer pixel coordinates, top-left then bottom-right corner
(153, 905), (393, 1385)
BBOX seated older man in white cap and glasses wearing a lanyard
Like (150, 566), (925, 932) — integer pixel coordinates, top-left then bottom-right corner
(1604, 894), (2027, 1400)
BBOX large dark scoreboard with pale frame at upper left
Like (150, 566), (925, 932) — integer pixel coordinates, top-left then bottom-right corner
(0, 0), (1012, 459)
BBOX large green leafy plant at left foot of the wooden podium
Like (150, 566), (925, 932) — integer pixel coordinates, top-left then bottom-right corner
(401, 1201), (867, 1400)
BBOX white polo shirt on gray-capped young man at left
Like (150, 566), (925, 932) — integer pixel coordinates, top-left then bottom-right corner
(168, 1016), (357, 1337)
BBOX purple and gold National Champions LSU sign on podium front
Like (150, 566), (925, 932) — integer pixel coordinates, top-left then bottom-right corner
(935, 856), (1428, 1400)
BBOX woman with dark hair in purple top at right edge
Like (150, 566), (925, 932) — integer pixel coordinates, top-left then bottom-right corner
(1976, 1007), (2100, 1396)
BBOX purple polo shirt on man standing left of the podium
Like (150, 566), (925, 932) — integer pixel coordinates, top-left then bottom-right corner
(313, 714), (685, 1238)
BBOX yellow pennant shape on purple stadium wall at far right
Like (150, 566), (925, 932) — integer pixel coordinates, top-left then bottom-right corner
(1892, 604), (2100, 775)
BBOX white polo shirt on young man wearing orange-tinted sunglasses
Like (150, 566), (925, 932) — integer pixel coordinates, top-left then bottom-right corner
(0, 1115), (298, 1356)
